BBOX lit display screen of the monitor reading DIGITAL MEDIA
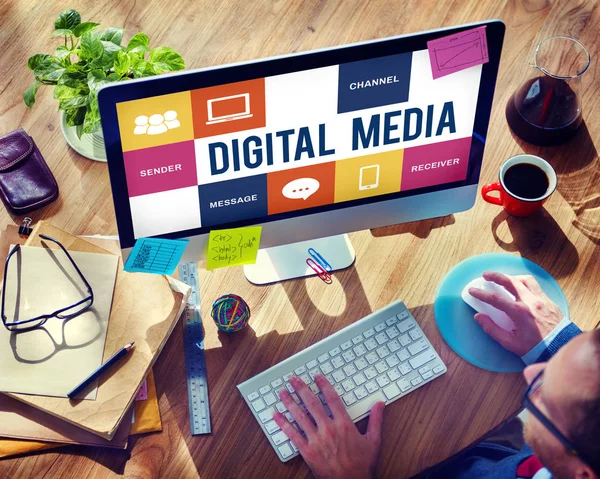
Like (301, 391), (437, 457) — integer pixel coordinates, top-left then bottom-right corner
(101, 20), (499, 247)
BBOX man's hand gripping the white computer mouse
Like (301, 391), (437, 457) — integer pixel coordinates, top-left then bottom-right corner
(469, 271), (563, 356)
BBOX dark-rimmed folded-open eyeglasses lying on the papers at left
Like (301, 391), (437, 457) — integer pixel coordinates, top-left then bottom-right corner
(0, 234), (94, 332)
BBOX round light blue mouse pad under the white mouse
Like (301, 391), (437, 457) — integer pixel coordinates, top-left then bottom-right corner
(434, 253), (569, 373)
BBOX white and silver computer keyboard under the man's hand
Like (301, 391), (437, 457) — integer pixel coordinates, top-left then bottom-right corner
(238, 301), (446, 462)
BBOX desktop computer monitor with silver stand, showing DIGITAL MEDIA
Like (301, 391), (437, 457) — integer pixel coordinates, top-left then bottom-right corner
(99, 20), (505, 283)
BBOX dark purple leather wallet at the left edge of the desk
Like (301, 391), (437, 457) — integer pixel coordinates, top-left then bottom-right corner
(0, 128), (58, 215)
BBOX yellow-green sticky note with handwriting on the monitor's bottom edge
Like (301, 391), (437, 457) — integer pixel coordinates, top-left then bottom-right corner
(206, 226), (262, 271)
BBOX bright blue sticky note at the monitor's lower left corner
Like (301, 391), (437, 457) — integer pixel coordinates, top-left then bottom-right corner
(123, 238), (189, 274)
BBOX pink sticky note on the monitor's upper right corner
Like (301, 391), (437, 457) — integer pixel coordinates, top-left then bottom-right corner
(427, 26), (490, 80)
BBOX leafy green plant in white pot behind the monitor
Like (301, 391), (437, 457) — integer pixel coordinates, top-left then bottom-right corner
(23, 9), (185, 161)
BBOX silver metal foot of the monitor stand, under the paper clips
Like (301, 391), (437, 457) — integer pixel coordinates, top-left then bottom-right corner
(244, 235), (356, 284)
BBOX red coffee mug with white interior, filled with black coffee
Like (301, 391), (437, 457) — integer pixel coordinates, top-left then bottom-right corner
(481, 155), (557, 216)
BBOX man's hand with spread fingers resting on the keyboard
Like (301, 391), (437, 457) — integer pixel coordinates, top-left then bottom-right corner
(273, 374), (384, 479)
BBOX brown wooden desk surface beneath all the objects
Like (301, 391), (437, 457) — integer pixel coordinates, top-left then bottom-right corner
(0, 0), (600, 478)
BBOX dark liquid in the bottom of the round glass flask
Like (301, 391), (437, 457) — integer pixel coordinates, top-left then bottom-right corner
(506, 76), (582, 146)
